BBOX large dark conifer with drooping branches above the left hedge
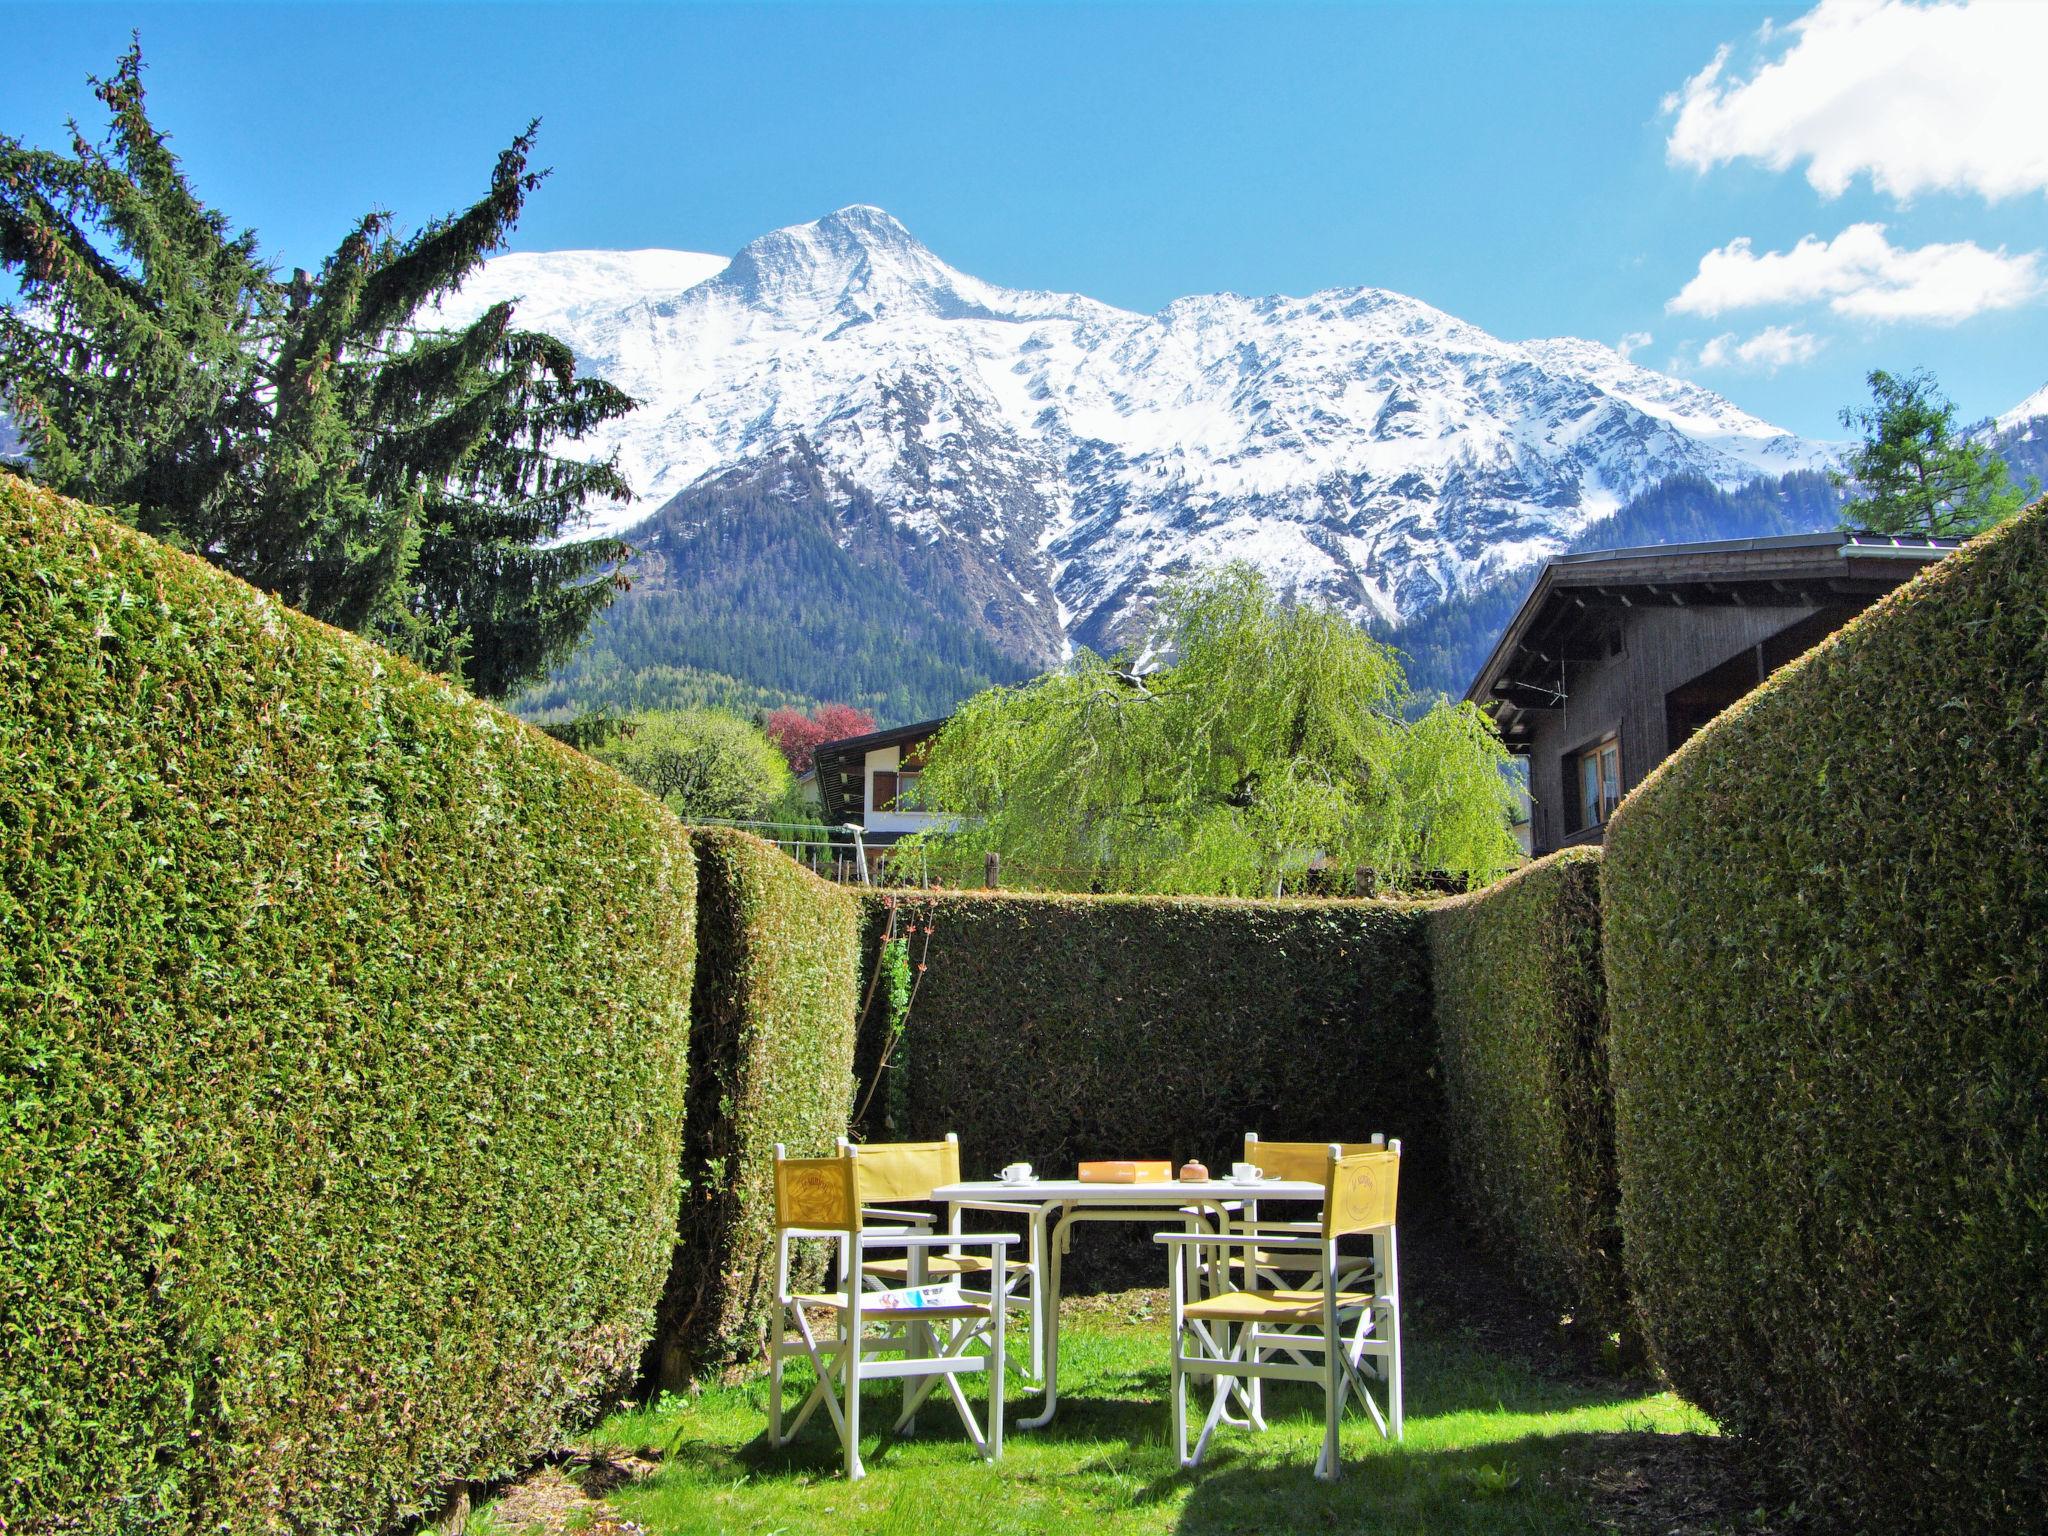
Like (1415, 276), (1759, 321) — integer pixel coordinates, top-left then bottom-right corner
(0, 47), (633, 696)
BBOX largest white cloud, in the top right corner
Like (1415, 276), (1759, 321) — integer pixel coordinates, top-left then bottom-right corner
(1665, 0), (2048, 201)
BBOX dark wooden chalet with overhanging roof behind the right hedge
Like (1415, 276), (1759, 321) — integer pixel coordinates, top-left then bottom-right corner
(1464, 532), (1956, 856)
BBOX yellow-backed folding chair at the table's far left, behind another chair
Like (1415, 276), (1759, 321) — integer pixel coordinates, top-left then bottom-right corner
(840, 1133), (1044, 1386)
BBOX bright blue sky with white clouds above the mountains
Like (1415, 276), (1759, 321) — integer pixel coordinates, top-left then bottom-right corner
(0, 0), (2048, 436)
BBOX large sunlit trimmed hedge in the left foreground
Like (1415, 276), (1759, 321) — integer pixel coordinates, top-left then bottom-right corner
(0, 473), (694, 1532)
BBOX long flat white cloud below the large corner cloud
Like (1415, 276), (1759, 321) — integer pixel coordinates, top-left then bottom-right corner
(1665, 223), (2048, 324)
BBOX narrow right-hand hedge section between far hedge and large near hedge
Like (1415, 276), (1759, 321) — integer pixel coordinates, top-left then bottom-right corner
(1427, 848), (1626, 1331)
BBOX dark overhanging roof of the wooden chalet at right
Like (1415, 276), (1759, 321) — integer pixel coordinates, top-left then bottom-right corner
(1464, 532), (1956, 731)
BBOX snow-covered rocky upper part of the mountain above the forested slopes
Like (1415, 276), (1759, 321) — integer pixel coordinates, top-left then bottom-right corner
(436, 207), (1833, 664)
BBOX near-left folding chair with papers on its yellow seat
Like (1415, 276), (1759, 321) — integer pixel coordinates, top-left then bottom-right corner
(768, 1147), (1016, 1481)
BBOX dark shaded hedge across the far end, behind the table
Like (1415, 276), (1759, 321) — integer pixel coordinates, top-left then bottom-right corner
(905, 893), (1442, 1266)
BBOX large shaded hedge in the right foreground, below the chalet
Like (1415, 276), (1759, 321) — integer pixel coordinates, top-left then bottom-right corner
(1604, 504), (2048, 1532)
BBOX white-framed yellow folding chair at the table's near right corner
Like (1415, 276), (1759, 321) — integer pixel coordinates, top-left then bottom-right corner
(1153, 1143), (1401, 1479)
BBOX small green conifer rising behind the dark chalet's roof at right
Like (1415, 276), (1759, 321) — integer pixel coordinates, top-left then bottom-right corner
(1837, 369), (2025, 539)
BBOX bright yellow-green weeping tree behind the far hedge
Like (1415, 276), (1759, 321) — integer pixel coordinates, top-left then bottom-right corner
(922, 565), (1518, 895)
